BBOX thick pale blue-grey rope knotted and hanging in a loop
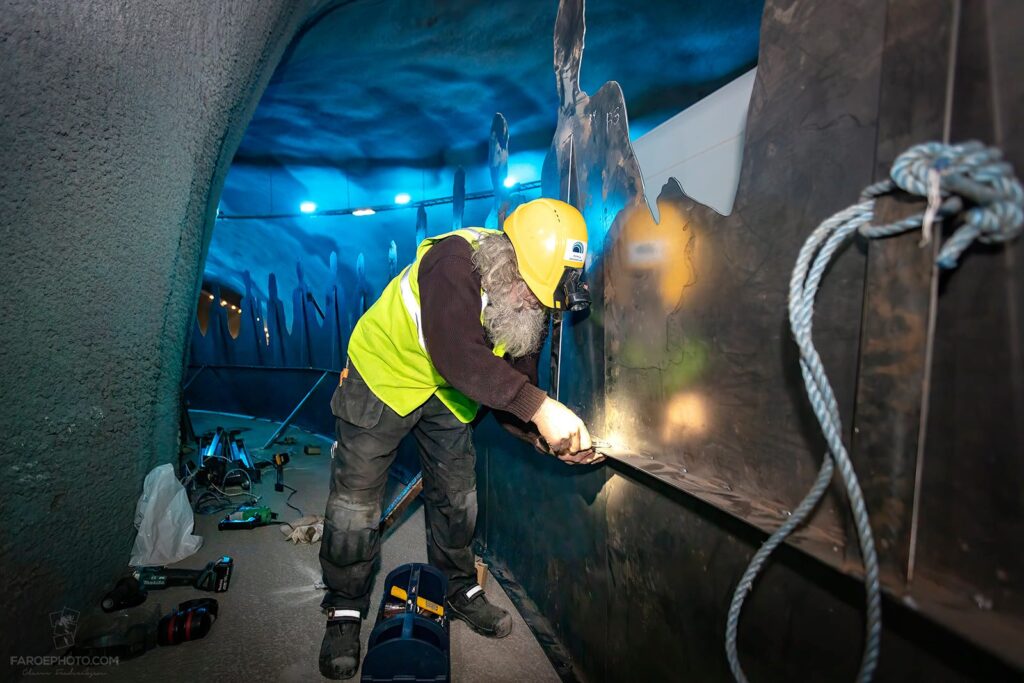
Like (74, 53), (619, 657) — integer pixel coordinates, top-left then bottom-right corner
(725, 142), (1024, 683)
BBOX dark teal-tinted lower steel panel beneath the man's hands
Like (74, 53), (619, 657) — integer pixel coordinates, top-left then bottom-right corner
(475, 420), (617, 681)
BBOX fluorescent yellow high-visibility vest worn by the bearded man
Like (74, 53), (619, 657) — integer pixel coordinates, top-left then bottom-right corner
(348, 227), (505, 423)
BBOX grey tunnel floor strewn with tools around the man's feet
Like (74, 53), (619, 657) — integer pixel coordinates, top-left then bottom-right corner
(104, 411), (559, 682)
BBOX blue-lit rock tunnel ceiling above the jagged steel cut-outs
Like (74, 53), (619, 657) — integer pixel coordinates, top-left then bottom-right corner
(205, 0), (763, 325)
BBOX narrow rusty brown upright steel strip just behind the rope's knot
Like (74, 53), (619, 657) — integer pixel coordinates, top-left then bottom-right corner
(851, 0), (953, 591)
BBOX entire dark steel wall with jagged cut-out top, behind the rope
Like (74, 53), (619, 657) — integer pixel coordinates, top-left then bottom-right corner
(477, 0), (1024, 681)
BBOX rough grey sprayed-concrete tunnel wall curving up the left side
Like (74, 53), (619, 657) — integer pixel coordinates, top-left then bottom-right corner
(0, 0), (315, 667)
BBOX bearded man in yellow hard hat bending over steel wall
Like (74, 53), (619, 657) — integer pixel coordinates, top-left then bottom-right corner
(319, 199), (600, 679)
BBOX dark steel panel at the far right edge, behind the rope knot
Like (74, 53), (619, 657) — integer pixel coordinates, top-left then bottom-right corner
(910, 2), (1024, 667)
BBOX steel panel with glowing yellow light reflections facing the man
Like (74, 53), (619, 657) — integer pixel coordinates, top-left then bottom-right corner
(603, 2), (886, 572)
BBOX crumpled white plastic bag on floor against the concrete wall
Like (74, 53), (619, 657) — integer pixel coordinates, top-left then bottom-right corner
(128, 465), (203, 567)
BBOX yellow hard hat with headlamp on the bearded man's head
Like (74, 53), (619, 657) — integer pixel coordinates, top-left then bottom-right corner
(505, 199), (590, 310)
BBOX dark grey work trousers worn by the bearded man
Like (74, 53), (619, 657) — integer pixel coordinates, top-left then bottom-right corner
(319, 366), (476, 617)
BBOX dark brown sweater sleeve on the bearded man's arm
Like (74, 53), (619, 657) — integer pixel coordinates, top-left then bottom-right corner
(419, 237), (547, 422)
